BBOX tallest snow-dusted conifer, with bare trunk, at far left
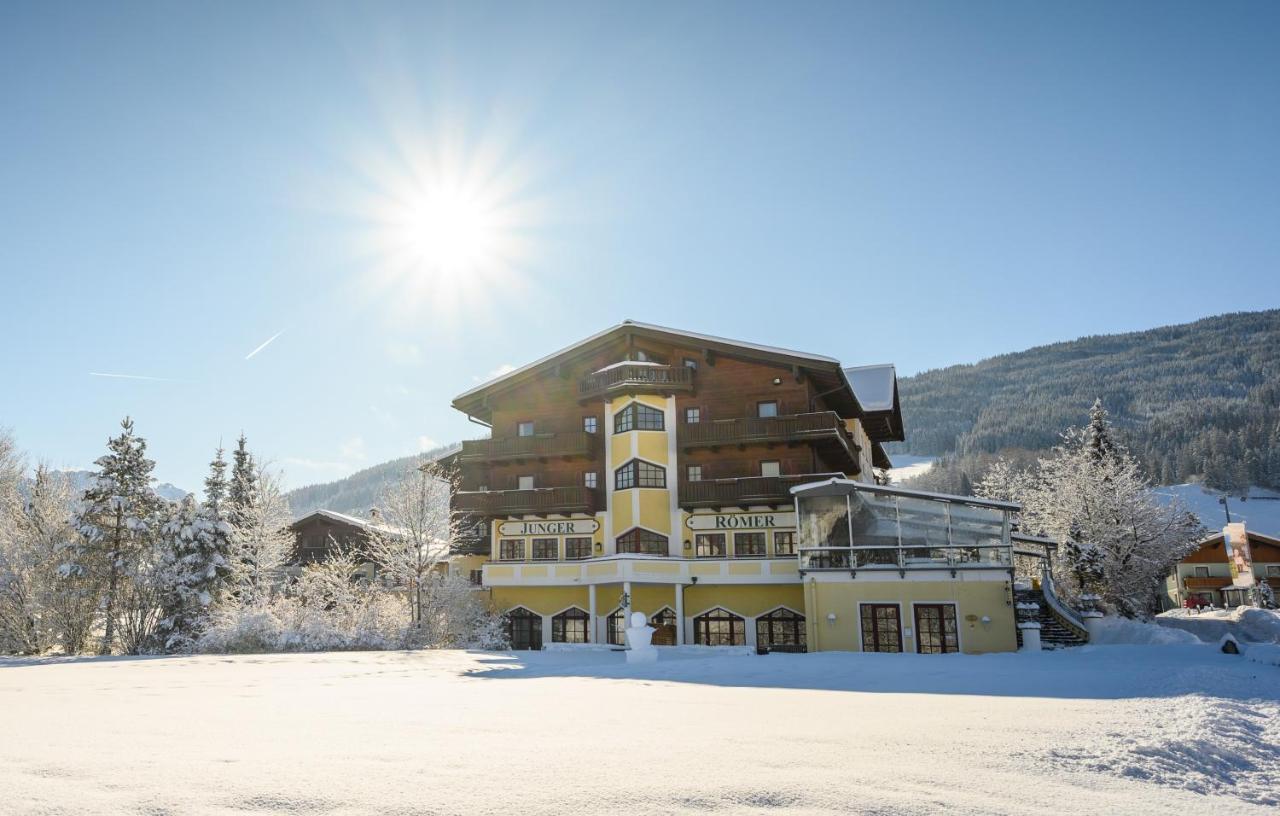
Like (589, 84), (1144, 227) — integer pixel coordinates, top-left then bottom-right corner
(71, 417), (160, 654)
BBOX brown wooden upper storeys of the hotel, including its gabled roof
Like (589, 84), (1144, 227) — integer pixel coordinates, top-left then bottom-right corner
(453, 322), (902, 549)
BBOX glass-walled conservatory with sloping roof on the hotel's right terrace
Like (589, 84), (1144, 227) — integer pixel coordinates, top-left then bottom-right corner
(791, 478), (1018, 572)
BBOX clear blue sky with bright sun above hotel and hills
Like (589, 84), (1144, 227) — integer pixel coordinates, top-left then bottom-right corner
(0, 3), (1280, 489)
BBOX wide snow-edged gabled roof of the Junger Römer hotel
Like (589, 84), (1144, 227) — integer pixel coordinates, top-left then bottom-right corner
(453, 320), (863, 421)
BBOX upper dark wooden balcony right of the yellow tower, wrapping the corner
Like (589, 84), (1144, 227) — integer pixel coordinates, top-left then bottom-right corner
(677, 411), (859, 473)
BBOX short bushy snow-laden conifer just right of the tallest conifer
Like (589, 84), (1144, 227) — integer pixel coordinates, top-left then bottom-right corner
(160, 496), (232, 652)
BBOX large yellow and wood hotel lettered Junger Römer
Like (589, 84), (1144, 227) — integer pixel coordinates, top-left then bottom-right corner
(451, 321), (1016, 652)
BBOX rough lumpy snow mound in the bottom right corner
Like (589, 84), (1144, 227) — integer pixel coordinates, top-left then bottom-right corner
(1048, 694), (1280, 806)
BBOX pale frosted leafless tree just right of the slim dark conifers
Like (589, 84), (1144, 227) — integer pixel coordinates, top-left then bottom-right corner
(228, 467), (293, 606)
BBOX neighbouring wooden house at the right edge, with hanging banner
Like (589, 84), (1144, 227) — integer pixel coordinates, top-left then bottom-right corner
(1166, 523), (1280, 606)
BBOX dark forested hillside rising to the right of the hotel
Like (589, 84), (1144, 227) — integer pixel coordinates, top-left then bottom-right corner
(891, 310), (1280, 490)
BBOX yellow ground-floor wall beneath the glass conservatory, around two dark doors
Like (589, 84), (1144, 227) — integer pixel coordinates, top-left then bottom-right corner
(805, 581), (1018, 654)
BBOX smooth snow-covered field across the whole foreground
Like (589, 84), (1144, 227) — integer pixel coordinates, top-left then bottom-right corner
(0, 645), (1280, 816)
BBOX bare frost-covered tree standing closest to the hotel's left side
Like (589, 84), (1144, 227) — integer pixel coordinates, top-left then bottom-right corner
(367, 458), (458, 636)
